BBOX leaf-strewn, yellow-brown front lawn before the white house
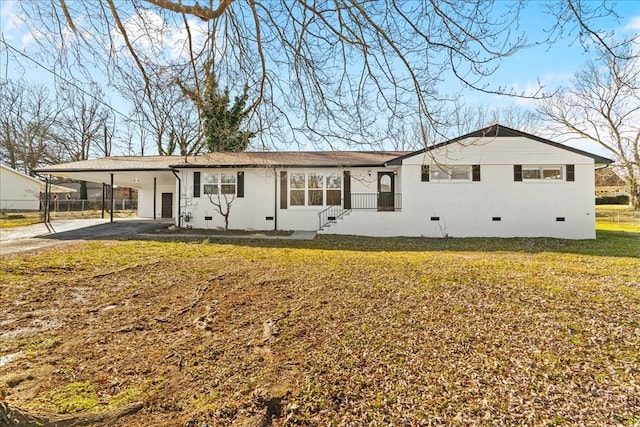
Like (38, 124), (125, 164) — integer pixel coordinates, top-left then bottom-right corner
(0, 236), (640, 426)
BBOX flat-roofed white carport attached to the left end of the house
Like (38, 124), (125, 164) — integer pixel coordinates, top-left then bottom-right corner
(36, 156), (182, 222)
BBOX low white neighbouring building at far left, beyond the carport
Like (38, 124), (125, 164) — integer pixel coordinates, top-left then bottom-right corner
(0, 164), (75, 212)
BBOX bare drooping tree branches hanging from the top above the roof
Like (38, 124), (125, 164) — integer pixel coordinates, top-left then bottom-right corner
(22, 0), (536, 150)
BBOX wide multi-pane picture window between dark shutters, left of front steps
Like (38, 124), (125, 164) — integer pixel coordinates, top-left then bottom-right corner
(289, 172), (342, 206)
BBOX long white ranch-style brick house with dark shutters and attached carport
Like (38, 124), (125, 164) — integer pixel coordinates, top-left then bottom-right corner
(38, 125), (612, 239)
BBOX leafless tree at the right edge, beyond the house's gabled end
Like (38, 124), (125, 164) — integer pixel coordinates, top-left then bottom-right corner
(538, 43), (640, 210)
